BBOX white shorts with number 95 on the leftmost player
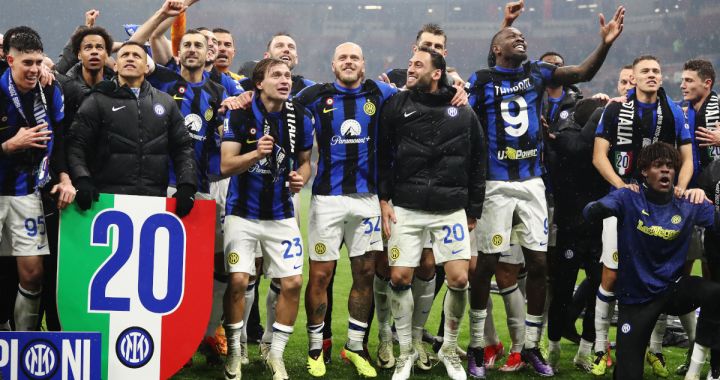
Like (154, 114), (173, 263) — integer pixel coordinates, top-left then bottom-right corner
(0, 192), (50, 256)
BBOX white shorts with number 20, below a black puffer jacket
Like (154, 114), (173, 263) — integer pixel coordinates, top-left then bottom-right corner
(388, 206), (470, 268)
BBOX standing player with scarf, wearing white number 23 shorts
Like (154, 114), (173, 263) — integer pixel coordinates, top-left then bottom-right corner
(220, 58), (313, 380)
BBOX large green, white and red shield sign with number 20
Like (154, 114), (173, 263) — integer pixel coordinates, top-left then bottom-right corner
(58, 194), (215, 379)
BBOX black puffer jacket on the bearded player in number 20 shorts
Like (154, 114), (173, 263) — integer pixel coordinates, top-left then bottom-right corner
(379, 87), (487, 218)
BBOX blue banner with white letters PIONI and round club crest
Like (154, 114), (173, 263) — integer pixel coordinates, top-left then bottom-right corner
(0, 331), (102, 380)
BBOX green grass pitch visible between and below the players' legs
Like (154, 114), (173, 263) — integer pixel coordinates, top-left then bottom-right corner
(173, 190), (696, 380)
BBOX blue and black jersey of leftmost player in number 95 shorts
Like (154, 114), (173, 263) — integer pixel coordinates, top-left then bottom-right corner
(0, 70), (65, 196)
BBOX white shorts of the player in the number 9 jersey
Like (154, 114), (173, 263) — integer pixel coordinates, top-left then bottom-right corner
(475, 178), (549, 254)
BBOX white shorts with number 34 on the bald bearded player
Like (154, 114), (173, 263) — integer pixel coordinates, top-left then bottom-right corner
(308, 193), (382, 261)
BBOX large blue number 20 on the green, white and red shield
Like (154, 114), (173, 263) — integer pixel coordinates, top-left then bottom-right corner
(90, 210), (185, 314)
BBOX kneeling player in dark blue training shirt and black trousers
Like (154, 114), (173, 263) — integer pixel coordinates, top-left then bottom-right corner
(584, 142), (720, 379)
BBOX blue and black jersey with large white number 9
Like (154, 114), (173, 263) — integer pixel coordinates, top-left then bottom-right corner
(467, 61), (555, 181)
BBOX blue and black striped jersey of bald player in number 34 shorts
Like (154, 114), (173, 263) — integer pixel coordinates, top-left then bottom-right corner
(296, 79), (397, 195)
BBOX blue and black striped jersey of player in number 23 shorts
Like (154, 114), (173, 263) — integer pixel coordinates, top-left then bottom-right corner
(223, 97), (313, 220)
